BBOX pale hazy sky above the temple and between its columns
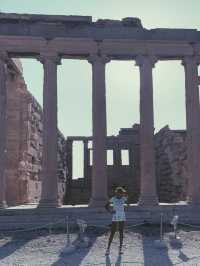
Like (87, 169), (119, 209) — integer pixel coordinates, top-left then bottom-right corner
(0, 0), (200, 175)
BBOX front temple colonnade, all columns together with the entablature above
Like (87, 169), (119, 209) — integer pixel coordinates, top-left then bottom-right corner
(0, 13), (200, 209)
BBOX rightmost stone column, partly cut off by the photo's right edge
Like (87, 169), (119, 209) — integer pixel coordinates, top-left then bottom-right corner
(182, 56), (200, 204)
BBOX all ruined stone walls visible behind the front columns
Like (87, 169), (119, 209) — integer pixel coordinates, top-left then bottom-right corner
(5, 61), (188, 205)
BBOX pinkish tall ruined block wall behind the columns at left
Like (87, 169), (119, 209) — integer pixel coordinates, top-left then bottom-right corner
(5, 59), (65, 205)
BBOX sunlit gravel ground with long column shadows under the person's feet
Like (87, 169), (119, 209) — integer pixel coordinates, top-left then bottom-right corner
(0, 226), (200, 266)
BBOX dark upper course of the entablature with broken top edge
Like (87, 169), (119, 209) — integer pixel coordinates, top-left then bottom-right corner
(0, 13), (200, 42)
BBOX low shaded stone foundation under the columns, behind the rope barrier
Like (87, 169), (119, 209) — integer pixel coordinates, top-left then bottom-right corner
(0, 203), (200, 230)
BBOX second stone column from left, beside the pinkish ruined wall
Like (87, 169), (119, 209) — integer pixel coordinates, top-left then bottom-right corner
(38, 52), (60, 208)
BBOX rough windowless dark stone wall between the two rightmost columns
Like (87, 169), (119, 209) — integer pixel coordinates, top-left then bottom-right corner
(155, 126), (188, 202)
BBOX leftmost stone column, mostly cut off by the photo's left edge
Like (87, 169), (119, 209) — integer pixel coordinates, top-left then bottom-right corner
(0, 52), (7, 209)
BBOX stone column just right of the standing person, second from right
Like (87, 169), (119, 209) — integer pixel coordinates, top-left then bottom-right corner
(136, 56), (158, 206)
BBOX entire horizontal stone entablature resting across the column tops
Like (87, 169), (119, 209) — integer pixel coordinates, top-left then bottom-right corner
(0, 13), (200, 60)
